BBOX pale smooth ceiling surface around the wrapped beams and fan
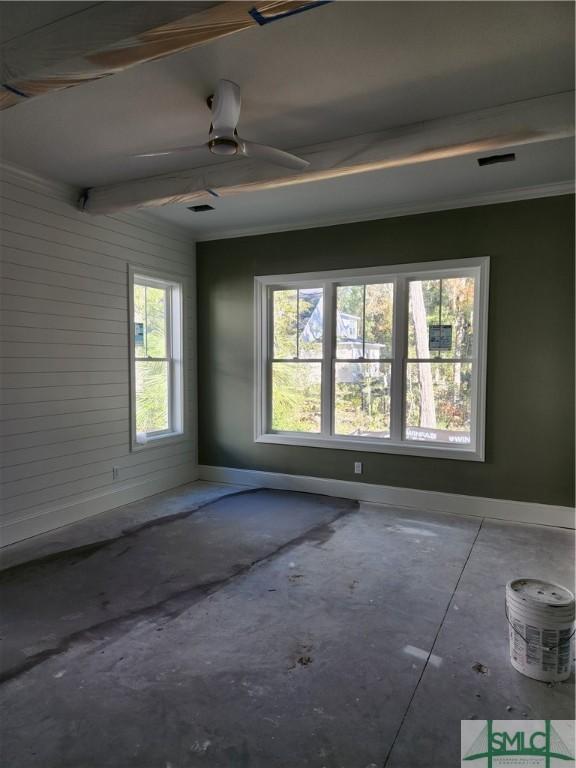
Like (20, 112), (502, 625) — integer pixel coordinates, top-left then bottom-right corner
(0, 0), (574, 237)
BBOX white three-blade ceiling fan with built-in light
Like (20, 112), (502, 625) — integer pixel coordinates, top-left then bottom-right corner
(132, 80), (310, 171)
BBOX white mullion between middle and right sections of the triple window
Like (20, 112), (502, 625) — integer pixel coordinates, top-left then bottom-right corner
(390, 277), (408, 442)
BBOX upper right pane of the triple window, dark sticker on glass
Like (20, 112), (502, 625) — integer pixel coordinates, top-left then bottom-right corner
(408, 277), (474, 358)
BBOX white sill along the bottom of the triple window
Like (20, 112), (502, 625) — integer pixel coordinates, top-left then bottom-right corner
(254, 432), (484, 461)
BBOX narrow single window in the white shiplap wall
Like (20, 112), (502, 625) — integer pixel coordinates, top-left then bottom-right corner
(130, 268), (184, 449)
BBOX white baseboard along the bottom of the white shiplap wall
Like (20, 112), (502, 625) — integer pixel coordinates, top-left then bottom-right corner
(0, 466), (198, 547)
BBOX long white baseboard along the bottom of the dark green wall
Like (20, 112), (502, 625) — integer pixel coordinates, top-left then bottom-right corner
(198, 465), (575, 528)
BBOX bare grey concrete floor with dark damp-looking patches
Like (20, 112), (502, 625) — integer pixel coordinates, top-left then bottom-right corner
(0, 483), (574, 768)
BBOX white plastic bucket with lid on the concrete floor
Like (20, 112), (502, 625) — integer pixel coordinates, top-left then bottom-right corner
(506, 579), (575, 682)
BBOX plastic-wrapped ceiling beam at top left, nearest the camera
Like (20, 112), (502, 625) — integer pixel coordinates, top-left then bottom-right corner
(0, 0), (322, 109)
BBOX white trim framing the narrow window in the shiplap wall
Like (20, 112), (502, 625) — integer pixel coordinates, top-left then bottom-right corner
(128, 264), (187, 451)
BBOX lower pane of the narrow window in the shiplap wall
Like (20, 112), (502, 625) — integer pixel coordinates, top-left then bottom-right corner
(135, 360), (170, 433)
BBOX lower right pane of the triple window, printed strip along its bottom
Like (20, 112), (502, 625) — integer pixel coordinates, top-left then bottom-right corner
(406, 363), (472, 444)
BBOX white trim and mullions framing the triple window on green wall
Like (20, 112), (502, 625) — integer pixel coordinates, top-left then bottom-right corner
(254, 256), (490, 461)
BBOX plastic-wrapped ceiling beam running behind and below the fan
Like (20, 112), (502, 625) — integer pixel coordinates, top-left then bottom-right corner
(82, 91), (574, 214)
